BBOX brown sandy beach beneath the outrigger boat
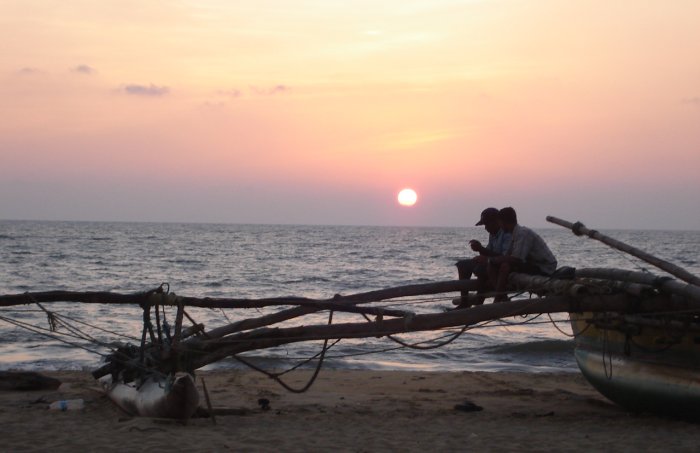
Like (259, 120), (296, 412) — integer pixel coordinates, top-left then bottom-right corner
(0, 370), (700, 452)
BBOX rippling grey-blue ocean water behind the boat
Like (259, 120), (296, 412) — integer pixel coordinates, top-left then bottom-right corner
(0, 217), (700, 372)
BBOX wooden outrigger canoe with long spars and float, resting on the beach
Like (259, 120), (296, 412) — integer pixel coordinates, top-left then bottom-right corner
(0, 217), (700, 419)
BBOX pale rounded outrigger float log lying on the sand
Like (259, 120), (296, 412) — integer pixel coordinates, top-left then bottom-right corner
(102, 373), (199, 419)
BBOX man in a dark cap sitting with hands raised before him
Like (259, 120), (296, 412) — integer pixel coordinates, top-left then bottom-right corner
(452, 208), (511, 308)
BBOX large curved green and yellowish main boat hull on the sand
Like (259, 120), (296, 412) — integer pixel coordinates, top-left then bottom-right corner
(570, 313), (700, 417)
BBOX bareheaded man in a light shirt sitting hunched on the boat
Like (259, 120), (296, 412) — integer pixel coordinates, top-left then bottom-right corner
(488, 207), (557, 302)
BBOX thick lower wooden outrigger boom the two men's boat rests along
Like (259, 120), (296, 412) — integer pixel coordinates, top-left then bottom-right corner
(187, 294), (700, 369)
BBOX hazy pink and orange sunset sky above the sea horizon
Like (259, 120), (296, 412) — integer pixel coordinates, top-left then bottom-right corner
(0, 0), (700, 226)
